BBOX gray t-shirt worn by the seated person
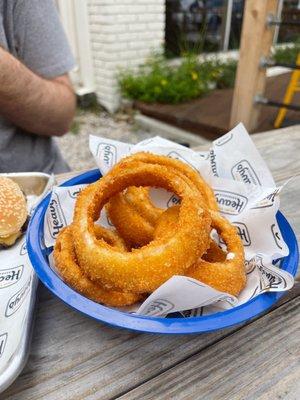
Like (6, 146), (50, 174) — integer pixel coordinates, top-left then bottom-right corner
(0, 0), (74, 173)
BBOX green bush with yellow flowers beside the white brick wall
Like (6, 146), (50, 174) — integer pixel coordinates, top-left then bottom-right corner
(119, 54), (236, 104)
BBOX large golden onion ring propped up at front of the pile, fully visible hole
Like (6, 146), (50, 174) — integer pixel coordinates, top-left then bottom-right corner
(73, 158), (211, 293)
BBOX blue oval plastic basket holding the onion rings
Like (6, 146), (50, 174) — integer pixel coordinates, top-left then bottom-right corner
(27, 170), (299, 334)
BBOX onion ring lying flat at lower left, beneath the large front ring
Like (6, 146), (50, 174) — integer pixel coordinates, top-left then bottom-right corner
(53, 226), (142, 307)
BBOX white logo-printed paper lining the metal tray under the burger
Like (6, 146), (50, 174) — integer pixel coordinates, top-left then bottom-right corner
(0, 177), (54, 375)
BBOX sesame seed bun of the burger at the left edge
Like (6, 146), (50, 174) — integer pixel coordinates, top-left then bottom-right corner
(0, 176), (27, 246)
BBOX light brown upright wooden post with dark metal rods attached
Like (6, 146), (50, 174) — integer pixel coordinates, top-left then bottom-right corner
(230, 0), (278, 132)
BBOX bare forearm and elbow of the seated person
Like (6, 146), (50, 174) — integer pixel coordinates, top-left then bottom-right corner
(0, 47), (76, 136)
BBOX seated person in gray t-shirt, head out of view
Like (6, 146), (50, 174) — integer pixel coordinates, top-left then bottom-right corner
(0, 0), (76, 173)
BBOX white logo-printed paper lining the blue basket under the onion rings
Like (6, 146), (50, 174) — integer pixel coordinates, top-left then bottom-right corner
(44, 124), (294, 317)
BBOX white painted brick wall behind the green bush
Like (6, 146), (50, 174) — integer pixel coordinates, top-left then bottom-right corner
(88, 0), (165, 112)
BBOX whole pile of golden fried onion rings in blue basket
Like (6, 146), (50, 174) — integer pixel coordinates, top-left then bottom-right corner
(54, 153), (246, 306)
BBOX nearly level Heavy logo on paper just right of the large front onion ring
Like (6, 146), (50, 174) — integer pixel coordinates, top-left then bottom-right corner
(215, 190), (248, 215)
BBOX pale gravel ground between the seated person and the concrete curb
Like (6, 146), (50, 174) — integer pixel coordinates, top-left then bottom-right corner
(57, 111), (152, 171)
